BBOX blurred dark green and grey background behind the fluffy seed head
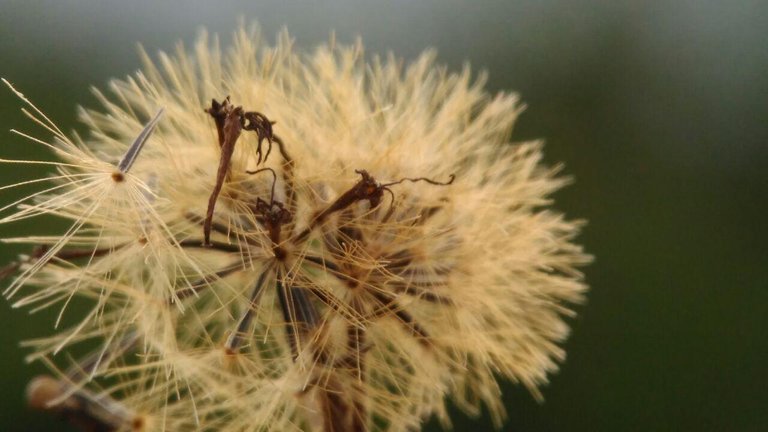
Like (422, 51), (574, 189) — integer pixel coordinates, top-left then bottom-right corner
(0, 0), (768, 431)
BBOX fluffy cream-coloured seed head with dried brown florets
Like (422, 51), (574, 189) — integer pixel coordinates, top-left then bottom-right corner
(0, 24), (589, 431)
